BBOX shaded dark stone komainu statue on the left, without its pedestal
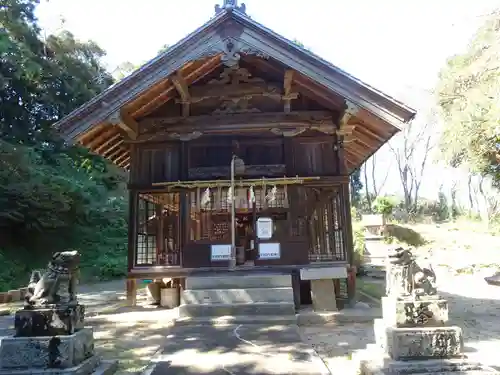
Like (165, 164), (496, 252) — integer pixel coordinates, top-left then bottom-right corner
(26, 251), (80, 306)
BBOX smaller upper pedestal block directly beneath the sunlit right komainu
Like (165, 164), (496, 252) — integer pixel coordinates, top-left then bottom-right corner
(382, 297), (448, 327)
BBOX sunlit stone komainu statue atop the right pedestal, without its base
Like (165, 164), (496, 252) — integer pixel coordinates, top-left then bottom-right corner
(386, 247), (437, 298)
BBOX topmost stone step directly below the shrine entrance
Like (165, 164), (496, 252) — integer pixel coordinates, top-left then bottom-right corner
(186, 273), (292, 290)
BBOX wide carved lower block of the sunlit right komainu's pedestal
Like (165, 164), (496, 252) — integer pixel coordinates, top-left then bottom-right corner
(381, 326), (464, 360)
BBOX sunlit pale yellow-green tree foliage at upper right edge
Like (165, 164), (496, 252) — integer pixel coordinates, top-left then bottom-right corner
(437, 11), (500, 186)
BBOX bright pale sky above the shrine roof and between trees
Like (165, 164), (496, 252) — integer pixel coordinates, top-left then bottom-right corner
(37, 0), (500, 201)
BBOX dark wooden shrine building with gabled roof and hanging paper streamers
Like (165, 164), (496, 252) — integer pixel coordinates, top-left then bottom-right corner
(55, 0), (415, 306)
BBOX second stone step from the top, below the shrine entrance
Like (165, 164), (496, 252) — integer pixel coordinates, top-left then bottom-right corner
(181, 287), (293, 305)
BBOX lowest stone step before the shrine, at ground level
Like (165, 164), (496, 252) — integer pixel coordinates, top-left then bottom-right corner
(174, 315), (297, 326)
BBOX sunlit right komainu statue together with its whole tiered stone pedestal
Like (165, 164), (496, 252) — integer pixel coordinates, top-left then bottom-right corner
(359, 248), (499, 375)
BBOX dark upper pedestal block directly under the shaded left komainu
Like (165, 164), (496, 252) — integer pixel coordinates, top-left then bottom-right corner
(14, 305), (85, 337)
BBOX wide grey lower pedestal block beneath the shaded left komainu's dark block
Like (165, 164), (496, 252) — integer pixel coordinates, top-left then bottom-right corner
(0, 328), (94, 374)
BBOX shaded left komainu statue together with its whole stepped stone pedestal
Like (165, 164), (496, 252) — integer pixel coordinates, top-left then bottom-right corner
(0, 251), (116, 375)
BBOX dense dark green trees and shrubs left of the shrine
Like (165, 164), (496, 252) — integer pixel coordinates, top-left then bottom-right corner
(0, 0), (127, 290)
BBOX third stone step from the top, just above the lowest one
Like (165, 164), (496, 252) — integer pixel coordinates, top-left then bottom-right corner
(179, 302), (295, 318)
